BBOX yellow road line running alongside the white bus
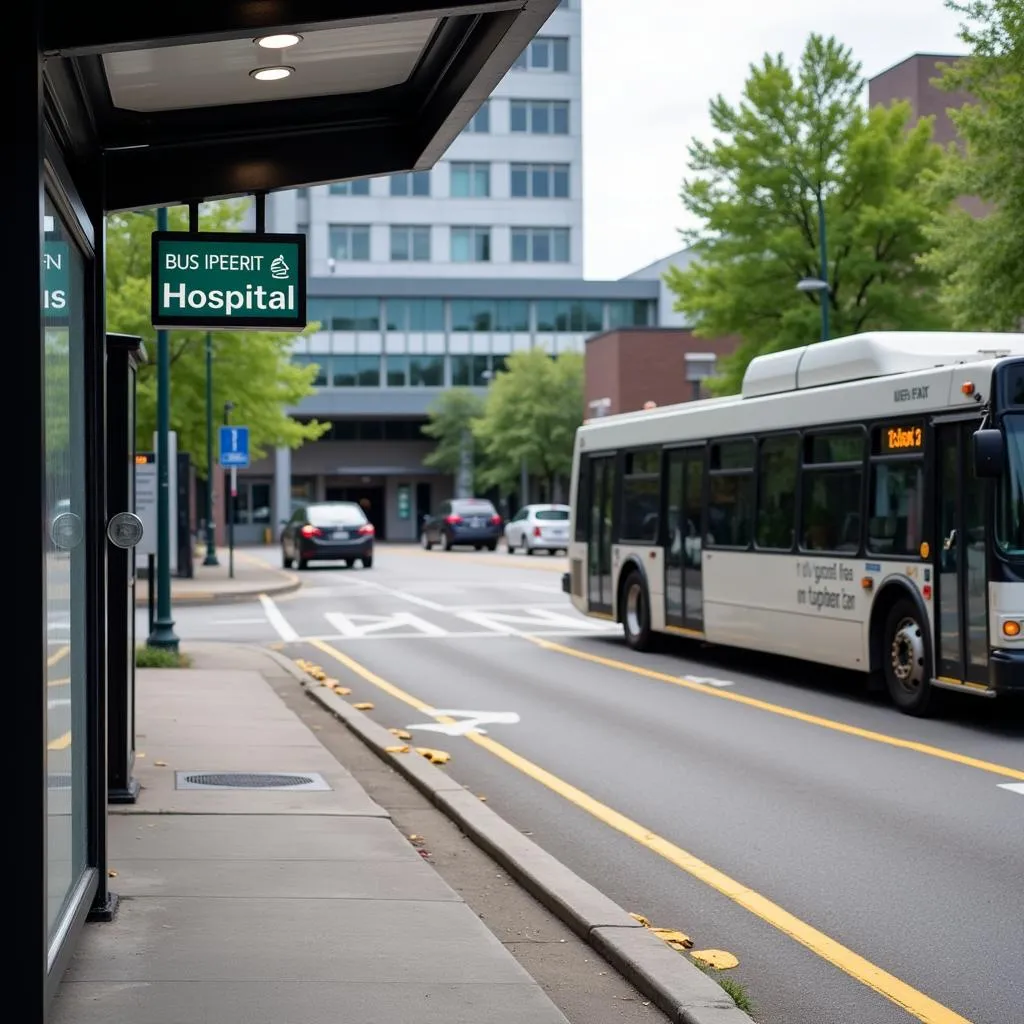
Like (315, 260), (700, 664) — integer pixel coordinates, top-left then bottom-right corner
(522, 634), (1024, 781)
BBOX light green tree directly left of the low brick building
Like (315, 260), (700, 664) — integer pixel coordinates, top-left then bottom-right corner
(475, 348), (584, 496)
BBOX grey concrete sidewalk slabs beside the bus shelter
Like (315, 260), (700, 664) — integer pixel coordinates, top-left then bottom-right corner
(52, 646), (565, 1024)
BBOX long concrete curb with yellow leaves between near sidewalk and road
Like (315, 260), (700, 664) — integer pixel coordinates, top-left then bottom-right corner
(264, 648), (754, 1024)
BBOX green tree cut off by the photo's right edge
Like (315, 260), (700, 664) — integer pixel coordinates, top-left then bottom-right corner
(924, 0), (1024, 331)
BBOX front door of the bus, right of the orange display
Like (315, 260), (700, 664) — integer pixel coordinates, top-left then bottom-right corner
(934, 420), (988, 686)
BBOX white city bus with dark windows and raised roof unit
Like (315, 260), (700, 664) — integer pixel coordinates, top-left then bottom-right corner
(562, 332), (1024, 715)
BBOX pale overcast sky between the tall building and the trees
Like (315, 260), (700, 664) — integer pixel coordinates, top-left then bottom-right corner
(581, 0), (964, 278)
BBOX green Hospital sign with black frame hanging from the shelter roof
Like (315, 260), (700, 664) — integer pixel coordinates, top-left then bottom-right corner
(152, 231), (306, 331)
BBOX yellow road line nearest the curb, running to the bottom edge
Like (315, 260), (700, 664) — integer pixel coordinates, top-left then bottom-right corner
(309, 640), (971, 1024)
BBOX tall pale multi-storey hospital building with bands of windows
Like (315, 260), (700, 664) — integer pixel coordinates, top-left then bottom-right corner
(237, 0), (663, 542)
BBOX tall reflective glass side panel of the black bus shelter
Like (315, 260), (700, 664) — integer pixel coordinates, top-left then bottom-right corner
(42, 197), (87, 940)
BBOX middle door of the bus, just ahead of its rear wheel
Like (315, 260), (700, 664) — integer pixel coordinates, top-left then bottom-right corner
(665, 445), (705, 631)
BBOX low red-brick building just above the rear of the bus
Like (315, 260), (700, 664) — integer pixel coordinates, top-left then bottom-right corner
(584, 327), (739, 419)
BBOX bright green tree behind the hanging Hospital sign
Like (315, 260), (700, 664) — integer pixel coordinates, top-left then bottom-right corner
(106, 201), (327, 476)
